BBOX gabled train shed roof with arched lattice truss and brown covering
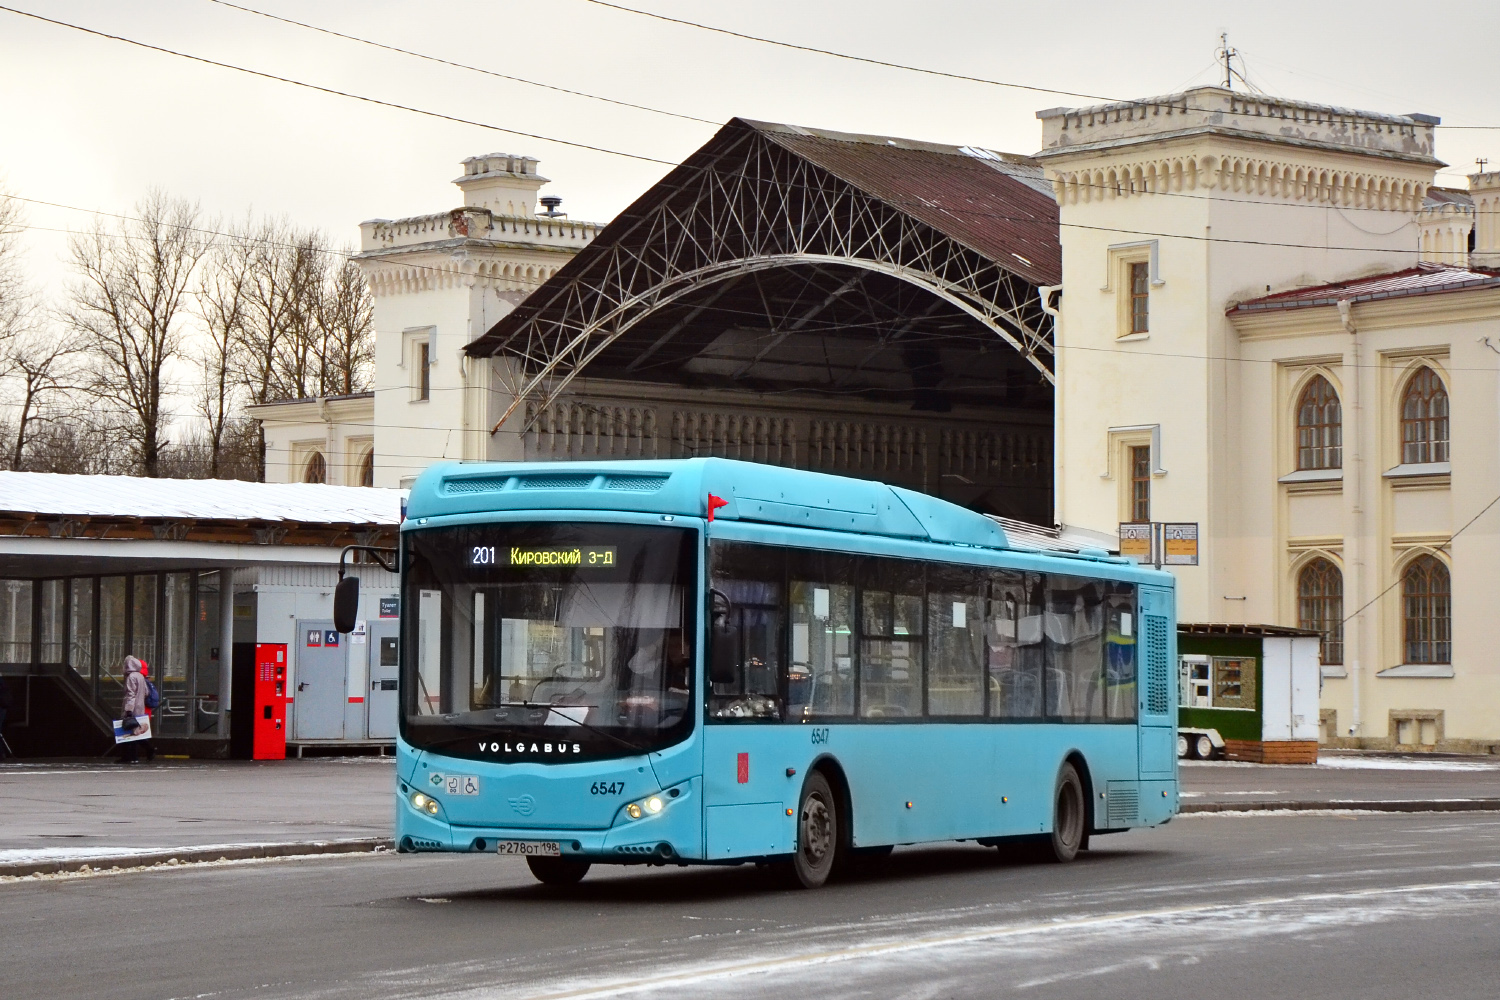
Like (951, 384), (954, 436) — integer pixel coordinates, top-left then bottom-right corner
(468, 118), (1062, 429)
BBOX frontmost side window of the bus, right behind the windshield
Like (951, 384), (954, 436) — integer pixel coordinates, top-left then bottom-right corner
(708, 541), (786, 721)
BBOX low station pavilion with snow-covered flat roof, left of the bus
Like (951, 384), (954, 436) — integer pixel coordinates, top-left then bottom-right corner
(0, 472), (402, 757)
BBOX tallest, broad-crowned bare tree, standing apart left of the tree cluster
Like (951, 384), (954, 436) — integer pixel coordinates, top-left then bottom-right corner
(65, 192), (209, 477)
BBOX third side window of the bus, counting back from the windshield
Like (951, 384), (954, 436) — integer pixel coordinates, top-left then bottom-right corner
(860, 559), (927, 718)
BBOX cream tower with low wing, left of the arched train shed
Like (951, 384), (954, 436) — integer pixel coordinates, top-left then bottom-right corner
(249, 153), (599, 487)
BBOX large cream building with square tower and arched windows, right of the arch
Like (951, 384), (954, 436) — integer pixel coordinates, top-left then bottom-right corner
(1038, 87), (1500, 750)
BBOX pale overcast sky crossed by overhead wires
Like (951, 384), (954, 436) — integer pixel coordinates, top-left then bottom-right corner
(0, 0), (1500, 301)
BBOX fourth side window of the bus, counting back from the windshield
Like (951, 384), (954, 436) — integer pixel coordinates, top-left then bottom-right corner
(927, 564), (984, 717)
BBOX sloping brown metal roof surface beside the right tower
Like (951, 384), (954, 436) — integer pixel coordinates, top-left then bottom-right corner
(740, 120), (1062, 285)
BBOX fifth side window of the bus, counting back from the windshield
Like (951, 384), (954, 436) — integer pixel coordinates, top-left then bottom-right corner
(986, 570), (1047, 718)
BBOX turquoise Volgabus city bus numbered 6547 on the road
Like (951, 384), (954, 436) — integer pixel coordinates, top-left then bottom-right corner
(396, 459), (1178, 888)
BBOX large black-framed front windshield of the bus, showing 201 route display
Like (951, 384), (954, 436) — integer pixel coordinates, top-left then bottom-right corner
(402, 523), (696, 760)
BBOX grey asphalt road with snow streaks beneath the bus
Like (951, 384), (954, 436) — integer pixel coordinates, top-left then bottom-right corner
(0, 813), (1500, 1000)
